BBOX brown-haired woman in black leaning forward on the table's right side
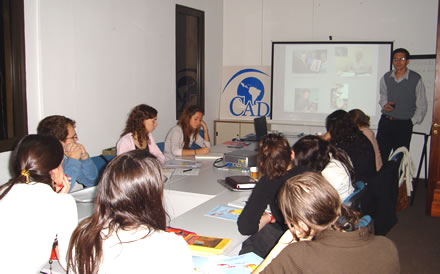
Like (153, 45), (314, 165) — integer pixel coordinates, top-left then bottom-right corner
(237, 134), (306, 258)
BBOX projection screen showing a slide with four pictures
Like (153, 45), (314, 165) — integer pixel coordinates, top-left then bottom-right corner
(272, 42), (392, 123)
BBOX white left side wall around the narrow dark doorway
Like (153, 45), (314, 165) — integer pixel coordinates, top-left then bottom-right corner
(0, 0), (223, 182)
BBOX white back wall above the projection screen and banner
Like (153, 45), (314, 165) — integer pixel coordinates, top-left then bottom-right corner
(223, 0), (438, 177)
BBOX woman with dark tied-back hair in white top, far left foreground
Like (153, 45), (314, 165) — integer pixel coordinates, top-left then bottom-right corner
(0, 135), (78, 273)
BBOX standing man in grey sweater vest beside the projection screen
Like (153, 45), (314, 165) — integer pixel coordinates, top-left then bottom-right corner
(377, 48), (427, 163)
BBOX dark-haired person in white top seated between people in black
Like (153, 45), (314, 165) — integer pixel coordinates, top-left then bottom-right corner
(293, 135), (355, 201)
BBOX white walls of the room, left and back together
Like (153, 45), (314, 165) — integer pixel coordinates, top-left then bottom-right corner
(0, 0), (437, 182)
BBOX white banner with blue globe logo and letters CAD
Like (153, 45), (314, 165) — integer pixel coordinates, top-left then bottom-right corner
(220, 66), (270, 120)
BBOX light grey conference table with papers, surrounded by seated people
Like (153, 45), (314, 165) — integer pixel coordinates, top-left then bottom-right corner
(72, 143), (256, 256)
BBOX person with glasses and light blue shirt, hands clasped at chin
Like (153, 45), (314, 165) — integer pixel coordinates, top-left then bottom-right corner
(37, 115), (98, 189)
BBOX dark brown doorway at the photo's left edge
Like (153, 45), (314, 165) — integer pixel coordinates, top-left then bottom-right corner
(0, 0), (27, 152)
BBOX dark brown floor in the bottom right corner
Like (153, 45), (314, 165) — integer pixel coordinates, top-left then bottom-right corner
(386, 182), (440, 273)
